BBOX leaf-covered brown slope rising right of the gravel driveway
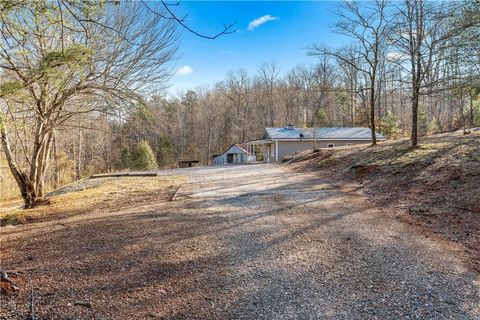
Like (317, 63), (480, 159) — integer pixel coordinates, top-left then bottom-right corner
(284, 130), (480, 271)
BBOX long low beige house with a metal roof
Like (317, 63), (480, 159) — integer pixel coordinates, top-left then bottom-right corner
(247, 125), (385, 162)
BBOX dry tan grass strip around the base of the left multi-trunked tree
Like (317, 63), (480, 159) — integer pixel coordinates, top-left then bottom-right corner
(0, 177), (185, 225)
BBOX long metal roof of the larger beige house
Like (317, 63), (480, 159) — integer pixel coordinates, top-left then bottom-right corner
(263, 127), (385, 140)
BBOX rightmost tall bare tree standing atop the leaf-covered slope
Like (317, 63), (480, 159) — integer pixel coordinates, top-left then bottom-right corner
(389, 0), (478, 147)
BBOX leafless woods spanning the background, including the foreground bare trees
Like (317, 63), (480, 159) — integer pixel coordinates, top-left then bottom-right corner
(0, 0), (480, 206)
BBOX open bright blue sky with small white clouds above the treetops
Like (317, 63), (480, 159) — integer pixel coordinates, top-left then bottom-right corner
(169, 1), (348, 94)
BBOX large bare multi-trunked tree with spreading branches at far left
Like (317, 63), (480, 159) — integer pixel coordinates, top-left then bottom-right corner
(0, 2), (177, 207)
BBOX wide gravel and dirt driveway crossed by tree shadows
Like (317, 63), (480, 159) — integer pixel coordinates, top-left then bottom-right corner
(0, 165), (480, 319)
